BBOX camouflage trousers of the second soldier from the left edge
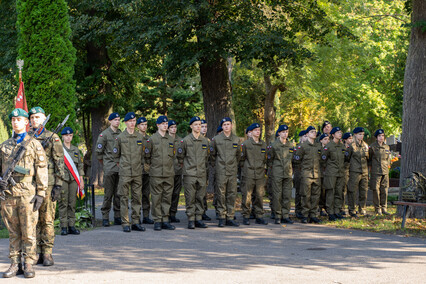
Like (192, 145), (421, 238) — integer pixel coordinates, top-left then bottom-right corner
(37, 185), (56, 254)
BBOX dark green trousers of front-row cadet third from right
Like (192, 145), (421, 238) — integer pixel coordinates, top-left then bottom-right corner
(323, 176), (345, 215)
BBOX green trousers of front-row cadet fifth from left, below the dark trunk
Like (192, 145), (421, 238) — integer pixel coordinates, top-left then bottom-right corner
(216, 174), (237, 220)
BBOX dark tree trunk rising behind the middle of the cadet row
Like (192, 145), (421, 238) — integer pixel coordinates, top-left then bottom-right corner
(200, 56), (232, 138)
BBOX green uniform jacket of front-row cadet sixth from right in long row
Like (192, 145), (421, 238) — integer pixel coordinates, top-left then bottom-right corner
(240, 137), (267, 179)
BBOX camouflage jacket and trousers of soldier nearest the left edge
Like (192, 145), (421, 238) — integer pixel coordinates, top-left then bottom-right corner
(0, 134), (50, 264)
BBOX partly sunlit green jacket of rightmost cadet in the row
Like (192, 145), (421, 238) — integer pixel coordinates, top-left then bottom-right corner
(368, 141), (391, 175)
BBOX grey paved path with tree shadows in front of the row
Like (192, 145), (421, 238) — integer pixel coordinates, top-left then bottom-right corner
(0, 207), (426, 284)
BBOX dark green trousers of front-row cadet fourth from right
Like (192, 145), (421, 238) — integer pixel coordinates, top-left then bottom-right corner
(300, 177), (321, 218)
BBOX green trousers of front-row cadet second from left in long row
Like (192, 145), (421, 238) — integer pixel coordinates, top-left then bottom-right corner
(118, 175), (142, 227)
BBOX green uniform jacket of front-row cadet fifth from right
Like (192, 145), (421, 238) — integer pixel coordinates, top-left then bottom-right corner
(268, 139), (294, 178)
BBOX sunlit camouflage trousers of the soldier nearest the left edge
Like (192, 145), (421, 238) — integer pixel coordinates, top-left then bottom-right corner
(1, 195), (38, 264)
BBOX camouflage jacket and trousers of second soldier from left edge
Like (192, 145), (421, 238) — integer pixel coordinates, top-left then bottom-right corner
(31, 128), (64, 254)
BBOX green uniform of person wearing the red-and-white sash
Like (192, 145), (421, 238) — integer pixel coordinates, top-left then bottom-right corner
(58, 145), (84, 228)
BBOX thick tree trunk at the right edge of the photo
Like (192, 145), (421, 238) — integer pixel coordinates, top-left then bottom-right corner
(399, 0), (426, 218)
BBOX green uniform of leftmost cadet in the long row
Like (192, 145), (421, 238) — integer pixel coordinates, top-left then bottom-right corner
(96, 127), (121, 220)
